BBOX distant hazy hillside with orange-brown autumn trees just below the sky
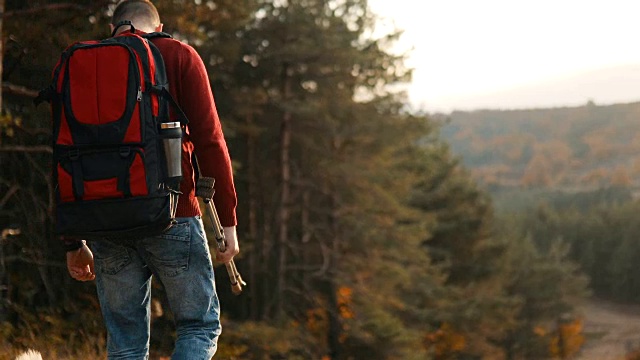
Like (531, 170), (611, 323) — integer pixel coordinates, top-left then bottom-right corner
(441, 102), (640, 190)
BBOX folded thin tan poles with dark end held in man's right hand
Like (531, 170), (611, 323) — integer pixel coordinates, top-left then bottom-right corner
(196, 176), (247, 295)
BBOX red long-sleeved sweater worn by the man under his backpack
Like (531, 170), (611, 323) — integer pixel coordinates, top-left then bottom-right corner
(152, 33), (237, 226)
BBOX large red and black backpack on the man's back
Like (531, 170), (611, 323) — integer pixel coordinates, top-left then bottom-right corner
(36, 22), (188, 240)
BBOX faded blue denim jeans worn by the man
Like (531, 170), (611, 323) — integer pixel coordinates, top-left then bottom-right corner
(91, 217), (221, 360)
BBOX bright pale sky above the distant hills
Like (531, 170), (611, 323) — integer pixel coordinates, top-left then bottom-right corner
(369, 0), (640, 112)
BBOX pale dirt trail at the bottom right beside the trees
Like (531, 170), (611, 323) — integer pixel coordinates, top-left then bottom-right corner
(577, 300), (640, 360)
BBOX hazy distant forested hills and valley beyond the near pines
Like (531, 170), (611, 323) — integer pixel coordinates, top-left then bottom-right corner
(439, 101), (640, 303)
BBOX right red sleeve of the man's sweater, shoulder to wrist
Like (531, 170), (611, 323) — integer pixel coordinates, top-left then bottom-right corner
(176, 44), (237, 226)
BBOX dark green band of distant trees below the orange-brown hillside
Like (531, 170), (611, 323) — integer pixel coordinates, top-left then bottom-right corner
(518, 195), (640, 302)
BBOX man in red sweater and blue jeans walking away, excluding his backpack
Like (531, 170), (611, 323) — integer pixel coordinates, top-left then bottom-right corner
(67, 0), (239, 359)
